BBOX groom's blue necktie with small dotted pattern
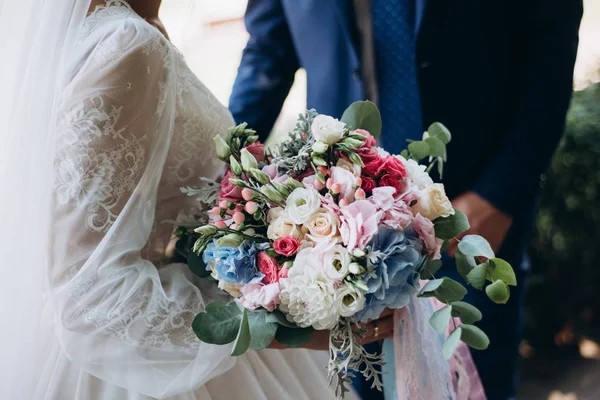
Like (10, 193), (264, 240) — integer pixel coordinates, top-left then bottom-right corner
(371, 0), (423, 154)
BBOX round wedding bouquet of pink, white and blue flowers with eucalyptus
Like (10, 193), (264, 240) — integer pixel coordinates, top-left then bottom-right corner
(173, 102), (516, 396)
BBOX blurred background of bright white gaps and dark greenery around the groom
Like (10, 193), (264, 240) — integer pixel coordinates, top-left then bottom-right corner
(161, 0), (600, 400)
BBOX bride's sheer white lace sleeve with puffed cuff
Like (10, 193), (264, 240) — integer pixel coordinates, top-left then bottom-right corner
(49, 18), (233, 398)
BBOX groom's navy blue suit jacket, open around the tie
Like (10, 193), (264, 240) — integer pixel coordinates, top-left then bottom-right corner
(229, 0), (583, 259)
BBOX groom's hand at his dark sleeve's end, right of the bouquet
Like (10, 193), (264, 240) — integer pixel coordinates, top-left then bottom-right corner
(448, 192), (512, 257)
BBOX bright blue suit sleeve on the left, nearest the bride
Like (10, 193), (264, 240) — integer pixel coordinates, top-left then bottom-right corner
(229, 0), (299, 140)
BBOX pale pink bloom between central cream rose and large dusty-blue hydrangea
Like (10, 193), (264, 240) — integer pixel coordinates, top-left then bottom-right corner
(340, 200), (383, 251)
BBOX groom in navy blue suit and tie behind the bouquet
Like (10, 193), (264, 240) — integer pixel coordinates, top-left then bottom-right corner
(230, 0), (582, 400)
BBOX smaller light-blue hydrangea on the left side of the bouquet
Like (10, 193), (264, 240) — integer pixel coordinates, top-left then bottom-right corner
(202, 240), (268, 285)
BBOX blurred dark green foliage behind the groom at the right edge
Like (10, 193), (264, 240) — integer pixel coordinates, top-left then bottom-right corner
(525, 80), (600, 348)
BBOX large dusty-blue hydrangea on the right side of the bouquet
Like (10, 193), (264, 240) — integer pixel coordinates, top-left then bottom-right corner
(356, 227), (425, 321)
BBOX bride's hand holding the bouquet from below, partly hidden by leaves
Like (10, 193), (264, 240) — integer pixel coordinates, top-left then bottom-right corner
(269, 310), (394, 350)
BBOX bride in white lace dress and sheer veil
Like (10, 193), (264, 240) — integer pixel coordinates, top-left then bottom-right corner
(0, 0), (476, 400)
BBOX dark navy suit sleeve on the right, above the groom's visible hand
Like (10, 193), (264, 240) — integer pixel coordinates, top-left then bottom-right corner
(475, 0), (583, 217)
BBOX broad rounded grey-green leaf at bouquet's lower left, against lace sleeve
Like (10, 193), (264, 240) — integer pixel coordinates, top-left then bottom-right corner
(192, 301), (243, 344)
